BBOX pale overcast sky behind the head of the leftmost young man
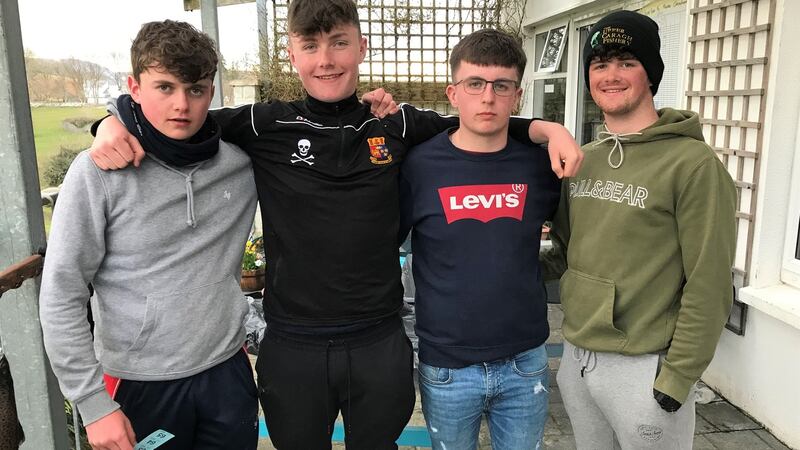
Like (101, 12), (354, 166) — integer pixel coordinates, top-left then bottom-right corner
(18, 0), (258, 71)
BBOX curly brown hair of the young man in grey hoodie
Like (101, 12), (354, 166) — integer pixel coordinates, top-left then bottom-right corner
(131, 20), (218, 83)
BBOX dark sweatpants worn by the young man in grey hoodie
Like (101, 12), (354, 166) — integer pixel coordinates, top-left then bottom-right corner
(114, 350), (258, 450)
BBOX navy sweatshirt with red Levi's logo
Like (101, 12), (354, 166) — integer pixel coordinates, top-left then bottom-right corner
(400, 130), (560, 368)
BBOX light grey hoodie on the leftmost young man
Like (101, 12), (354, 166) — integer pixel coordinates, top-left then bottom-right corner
(39, 142), (256, 424)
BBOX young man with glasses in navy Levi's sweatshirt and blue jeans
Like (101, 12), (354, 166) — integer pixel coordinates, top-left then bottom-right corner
(400, 30), (560, 450)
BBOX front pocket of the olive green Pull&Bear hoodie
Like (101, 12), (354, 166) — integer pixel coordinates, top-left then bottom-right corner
(560, 269), (628, 351)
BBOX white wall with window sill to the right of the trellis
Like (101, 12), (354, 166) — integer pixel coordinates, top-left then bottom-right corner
(703, 0), (800, 448)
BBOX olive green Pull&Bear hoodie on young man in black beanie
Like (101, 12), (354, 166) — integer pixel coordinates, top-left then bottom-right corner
(542, 109), (736, 402)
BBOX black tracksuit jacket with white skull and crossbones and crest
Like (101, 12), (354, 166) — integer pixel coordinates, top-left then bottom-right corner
(212, 95), (530, 328)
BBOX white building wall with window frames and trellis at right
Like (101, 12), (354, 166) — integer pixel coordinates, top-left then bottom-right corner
(523, 0), (800, 449)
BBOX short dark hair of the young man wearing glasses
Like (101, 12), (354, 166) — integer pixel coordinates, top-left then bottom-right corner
(450, 29), (528, 81)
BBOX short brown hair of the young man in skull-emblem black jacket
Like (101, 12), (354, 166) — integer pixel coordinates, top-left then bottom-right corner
(287, 0), (361, 36)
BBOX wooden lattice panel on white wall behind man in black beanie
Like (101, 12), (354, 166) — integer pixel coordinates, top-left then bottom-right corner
(686, 0), (776, 283)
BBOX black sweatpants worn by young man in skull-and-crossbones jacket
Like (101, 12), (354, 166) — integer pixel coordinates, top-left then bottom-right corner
(256, 317), (414, 450)
